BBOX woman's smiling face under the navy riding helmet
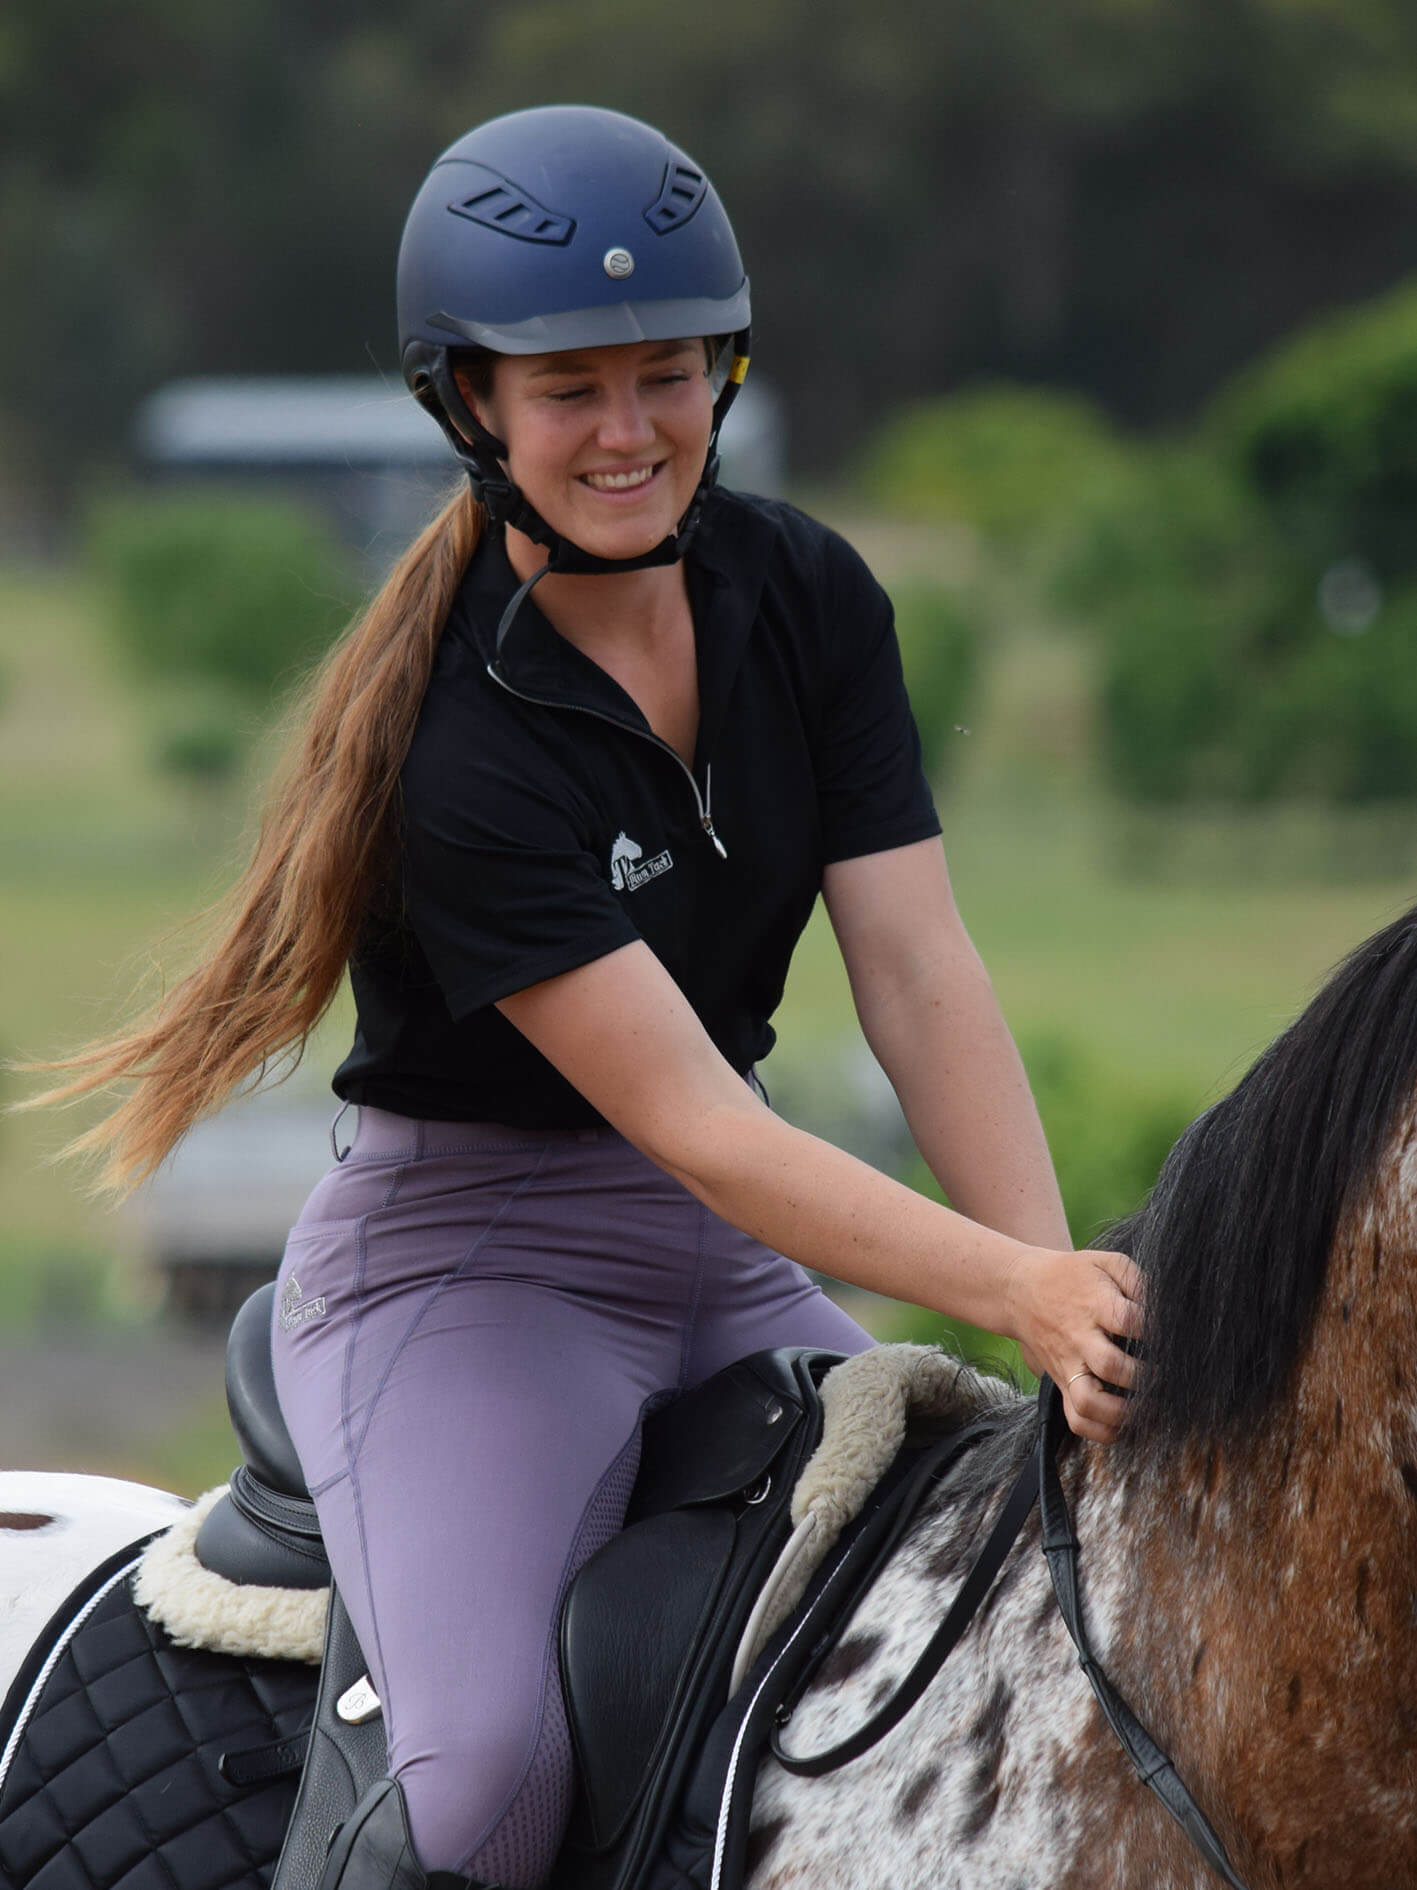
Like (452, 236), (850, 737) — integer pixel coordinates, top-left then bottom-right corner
(459, 340), (714, 558)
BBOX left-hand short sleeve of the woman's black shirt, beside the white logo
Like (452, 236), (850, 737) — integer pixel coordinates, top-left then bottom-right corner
(402, 725), (639, 1019)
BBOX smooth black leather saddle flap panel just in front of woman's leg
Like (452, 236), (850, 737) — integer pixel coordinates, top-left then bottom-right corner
(561, 1506), (737, 1848)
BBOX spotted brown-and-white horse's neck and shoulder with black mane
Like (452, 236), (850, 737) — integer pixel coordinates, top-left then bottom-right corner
(0, 915), (1417, 1890)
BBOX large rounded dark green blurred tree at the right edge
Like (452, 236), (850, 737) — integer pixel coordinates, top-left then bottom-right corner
(1056, 287), (1417, 803)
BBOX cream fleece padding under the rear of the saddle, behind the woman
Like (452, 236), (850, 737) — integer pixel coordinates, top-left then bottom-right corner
(132, 1484), (329, 1667)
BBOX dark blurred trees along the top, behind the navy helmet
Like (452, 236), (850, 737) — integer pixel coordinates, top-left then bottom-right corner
(0, 0), (1417, 514)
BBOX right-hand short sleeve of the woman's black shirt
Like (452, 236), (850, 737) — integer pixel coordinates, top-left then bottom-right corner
(814, 537), (939, 864)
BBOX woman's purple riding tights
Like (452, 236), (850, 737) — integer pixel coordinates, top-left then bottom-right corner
(264, 1109), (871, 1890)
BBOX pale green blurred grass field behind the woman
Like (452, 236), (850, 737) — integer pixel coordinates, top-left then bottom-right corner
(0, 540), (1413, 1489)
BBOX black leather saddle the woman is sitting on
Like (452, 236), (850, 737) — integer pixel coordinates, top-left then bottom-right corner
(196, 1285), (839, 1890)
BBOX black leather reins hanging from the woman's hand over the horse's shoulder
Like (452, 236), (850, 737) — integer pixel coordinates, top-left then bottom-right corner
(769, 1378), (1247, 1890)
